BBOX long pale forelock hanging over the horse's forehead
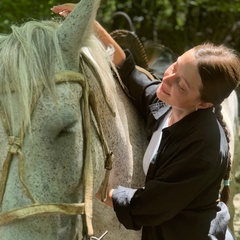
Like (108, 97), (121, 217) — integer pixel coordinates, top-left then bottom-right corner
(0, 21), (64, 134)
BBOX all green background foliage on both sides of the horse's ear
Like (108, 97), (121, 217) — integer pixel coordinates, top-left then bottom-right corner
(0, 0), (240, 53)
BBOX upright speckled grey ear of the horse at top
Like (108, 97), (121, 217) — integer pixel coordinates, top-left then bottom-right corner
(57, 0), (100, 70)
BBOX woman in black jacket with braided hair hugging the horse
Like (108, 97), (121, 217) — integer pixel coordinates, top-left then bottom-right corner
(52, 5), (240, 240)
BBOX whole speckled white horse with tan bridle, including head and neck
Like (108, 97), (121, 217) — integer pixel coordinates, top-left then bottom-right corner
(0, 0), (146, 240)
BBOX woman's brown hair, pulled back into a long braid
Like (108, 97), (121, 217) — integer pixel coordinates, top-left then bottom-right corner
(194, 43), (240, 203)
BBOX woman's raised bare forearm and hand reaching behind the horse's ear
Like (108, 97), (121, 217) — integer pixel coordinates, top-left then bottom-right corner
(51, 3), (126, 66)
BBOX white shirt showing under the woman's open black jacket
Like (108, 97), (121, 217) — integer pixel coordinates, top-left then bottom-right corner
(143, 111), (171, 175)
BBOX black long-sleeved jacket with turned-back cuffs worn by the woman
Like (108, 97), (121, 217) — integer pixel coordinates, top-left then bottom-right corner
(113, 49), (232, 240)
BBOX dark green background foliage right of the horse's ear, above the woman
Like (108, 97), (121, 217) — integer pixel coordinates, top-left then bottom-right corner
(99, 0), (240, 53)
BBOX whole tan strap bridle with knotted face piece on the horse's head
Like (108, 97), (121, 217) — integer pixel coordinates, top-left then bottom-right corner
(0, 67), (114, 238)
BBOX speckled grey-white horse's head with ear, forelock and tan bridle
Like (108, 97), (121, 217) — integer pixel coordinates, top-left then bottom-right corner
(0, 0), (108, 240)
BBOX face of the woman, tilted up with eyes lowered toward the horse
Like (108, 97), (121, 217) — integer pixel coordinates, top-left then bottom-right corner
(156, 49), (202, 112)
